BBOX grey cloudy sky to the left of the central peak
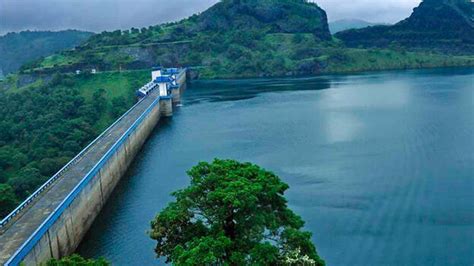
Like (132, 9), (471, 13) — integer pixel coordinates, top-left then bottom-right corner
(0, 0), (216, 34)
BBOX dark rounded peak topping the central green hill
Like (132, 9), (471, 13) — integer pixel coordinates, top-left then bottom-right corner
(197, 0), (331, 40)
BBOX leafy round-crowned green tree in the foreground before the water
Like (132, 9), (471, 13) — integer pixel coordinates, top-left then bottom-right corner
(150, 159), (324, 265)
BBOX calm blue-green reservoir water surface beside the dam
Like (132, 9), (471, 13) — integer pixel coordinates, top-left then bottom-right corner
(78, 68), (474, 266)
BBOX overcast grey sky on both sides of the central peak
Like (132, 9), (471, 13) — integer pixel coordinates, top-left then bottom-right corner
(0, 0), (421, 35)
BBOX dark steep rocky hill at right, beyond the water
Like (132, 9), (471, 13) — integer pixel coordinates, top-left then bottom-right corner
(336, 0), (474, 54)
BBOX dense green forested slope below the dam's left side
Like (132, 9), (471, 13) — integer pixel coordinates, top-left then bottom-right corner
(0, 71), (149, 217)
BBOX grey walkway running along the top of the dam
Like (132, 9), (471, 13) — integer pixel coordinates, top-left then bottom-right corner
(0, 90), (160, 265)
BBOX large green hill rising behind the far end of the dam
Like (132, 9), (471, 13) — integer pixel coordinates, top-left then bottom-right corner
(17, 0), (340, 78)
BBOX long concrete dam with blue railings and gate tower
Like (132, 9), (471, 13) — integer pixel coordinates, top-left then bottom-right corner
(0, 68), (186, 265)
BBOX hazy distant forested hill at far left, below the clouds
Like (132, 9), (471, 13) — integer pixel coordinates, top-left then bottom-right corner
(0, 30), (92, 75)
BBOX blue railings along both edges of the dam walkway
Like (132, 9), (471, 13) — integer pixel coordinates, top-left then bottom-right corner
(5, 94), (160, 265)
